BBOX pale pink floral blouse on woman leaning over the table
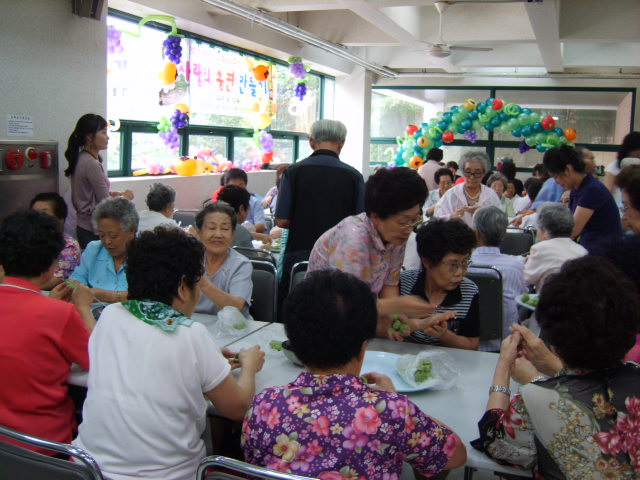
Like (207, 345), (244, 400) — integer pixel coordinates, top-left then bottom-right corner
(307, 213), (405, 295)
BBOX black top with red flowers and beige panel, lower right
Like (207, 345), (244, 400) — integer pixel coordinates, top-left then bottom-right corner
(472, 363), (640, 480)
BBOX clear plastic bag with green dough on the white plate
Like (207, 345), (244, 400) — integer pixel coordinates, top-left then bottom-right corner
(396, 350), (460, 390)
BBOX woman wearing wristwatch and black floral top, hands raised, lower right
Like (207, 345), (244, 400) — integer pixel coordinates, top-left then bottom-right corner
(477, 256), (640, 479)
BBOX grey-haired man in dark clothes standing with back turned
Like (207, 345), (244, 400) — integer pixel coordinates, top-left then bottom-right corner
(275, 120), (364, 294)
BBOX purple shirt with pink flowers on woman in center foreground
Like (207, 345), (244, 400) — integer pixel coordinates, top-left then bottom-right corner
(242, 372), (458, 480)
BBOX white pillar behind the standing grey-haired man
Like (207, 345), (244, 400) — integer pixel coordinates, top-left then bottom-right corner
(334, 66), (373, 181)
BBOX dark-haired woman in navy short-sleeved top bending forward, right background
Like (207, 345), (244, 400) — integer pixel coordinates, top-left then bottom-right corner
(543, 145), (622, 250)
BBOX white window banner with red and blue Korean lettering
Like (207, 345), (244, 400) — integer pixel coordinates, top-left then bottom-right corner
(188, 43), (269, 117)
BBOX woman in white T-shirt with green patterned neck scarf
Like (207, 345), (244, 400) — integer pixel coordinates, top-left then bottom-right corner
(74, 227), (264, 480)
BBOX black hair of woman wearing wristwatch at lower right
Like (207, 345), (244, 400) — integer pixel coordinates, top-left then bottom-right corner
(536, 255), (640, 370)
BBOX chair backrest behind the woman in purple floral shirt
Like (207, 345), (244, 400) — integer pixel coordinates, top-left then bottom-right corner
(196, 455), (312, 480)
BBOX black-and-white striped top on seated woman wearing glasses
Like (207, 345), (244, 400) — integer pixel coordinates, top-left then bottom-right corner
(400, 269), (480, 345)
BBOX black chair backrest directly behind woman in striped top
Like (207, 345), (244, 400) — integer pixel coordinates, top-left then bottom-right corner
(466, 264), (504, 341)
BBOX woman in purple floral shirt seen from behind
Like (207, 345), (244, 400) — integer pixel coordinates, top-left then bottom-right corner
(242, 270), (466, 480)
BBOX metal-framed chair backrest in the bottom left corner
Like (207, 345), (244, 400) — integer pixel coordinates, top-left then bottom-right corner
(0, 426), (102, 480)
